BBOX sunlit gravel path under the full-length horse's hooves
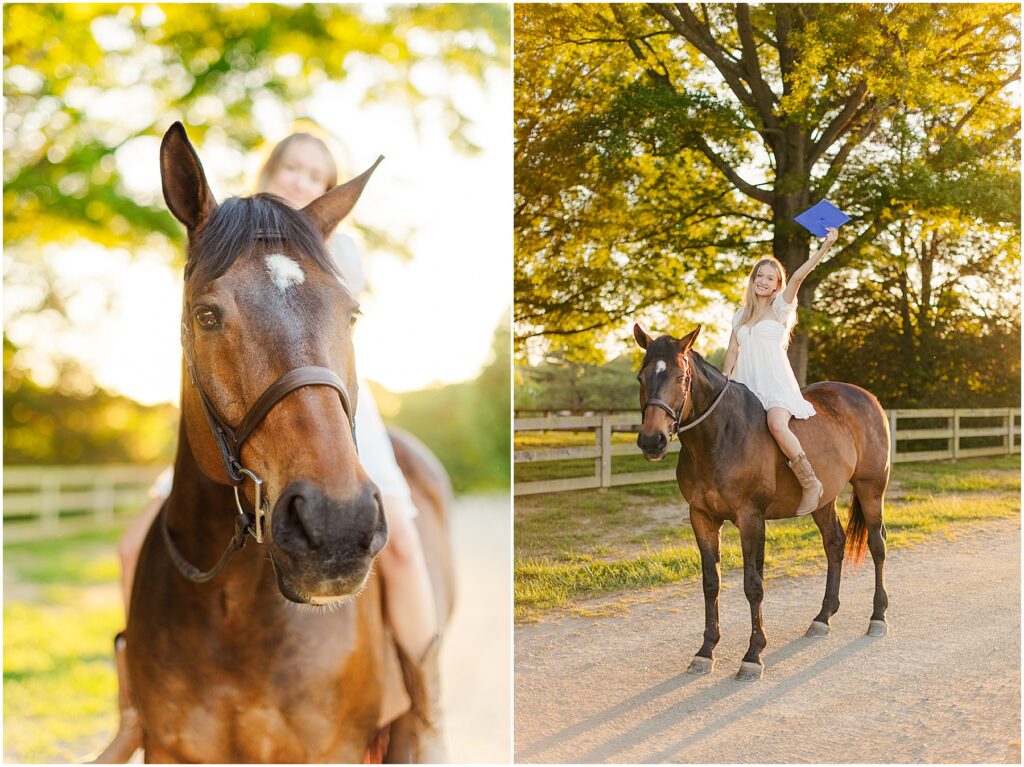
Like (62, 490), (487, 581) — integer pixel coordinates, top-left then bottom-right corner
(515, 518), (1021, 763)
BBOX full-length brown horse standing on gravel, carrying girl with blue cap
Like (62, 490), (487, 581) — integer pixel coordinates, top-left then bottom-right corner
(633, 325), (889, 680)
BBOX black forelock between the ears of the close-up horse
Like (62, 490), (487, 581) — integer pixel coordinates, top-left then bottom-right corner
(185, 194), (339, 286)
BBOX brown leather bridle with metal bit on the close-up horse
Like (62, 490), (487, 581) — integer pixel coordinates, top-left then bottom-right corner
(161, 231), (355, 583)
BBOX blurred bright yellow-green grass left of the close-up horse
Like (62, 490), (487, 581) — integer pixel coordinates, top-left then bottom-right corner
(3, 530), (124, 762)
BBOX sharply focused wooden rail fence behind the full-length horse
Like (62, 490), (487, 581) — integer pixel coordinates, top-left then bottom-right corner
(513, 408), (1021, 496)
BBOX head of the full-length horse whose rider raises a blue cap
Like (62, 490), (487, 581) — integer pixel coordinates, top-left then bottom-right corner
(633, 325), (700, 461)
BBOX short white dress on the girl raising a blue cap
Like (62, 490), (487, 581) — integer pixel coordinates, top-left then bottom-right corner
(732, 291), (814, 419)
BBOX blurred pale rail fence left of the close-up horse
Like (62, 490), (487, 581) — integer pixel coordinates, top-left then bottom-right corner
(3, 465), (165, 543)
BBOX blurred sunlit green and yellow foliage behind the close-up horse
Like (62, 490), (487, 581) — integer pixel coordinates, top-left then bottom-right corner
(3, 3), (511, 491)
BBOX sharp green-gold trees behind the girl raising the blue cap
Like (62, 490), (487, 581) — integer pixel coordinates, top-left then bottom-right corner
(514, 3), (1021, 408)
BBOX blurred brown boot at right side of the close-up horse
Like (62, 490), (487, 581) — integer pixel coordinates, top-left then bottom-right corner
(396, 636), (449, 764)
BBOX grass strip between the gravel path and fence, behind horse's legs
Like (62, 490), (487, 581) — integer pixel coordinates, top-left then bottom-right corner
(515, 456), (1021, 621)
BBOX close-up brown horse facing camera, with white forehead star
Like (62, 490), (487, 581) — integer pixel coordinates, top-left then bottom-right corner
(107, 123), (452, 763)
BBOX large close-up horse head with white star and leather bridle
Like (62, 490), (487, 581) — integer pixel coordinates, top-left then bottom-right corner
(160, 123), (387, 604)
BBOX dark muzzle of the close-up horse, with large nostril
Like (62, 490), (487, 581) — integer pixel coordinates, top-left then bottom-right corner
(270, 481), (387, 604)
